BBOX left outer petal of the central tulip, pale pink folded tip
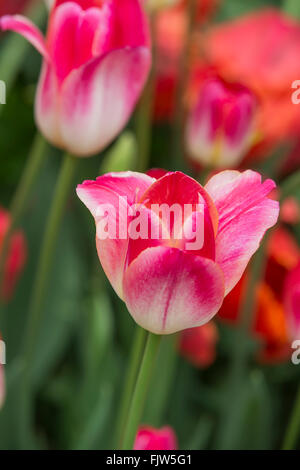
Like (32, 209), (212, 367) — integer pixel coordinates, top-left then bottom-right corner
(77, 172), (153, 298)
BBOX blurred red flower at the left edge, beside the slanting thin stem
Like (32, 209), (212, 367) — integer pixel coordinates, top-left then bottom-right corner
(0, 208), (27, 301)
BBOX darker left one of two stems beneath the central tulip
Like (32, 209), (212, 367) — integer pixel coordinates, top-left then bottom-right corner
(115, 325), (147, 448)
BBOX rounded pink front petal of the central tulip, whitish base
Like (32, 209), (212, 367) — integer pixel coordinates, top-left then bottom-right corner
(123, 246), (224, 334)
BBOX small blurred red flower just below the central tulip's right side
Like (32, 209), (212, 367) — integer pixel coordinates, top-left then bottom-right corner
(179, 321), (219, 367)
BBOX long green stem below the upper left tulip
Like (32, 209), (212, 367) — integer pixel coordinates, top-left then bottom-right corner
(20, 154), (78, 444)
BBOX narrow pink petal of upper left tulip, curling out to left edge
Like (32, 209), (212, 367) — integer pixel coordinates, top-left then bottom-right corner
(0, 15), (49, 60)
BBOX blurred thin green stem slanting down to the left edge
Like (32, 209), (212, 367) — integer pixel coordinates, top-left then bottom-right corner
(0, 134), (47, 316)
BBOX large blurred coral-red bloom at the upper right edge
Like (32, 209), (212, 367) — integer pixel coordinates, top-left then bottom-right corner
(199, 9), (300, 157)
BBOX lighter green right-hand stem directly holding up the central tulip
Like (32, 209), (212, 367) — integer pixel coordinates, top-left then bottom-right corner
(122, 333), (161, 450)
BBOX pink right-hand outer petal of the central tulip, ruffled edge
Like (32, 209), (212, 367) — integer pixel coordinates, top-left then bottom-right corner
(205, 170), (279, 294)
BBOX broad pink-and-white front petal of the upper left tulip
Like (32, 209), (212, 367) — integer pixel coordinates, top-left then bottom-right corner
(60, 47), (151, 156)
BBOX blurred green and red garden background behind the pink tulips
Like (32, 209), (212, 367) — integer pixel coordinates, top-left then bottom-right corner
(0, 0), (300, 449)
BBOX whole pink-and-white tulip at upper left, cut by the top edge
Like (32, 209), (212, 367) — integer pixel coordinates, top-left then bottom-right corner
(0, 0), (151, 156)
